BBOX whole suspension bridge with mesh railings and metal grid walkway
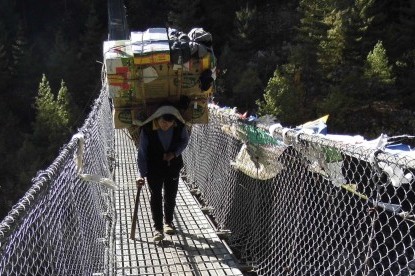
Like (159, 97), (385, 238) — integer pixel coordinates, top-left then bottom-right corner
(0, 1), (415, 276)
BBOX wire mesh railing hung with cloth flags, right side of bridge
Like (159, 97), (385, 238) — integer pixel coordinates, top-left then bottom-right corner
(185, 110), (415, 276)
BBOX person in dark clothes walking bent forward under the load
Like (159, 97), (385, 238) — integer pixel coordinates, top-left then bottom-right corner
(137, 105), (189, 241)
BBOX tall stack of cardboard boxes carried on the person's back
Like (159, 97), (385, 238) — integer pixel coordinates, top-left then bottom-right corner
(103, 28), (215, 141)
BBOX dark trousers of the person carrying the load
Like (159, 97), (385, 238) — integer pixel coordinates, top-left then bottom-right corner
(147, 176), (179, 231)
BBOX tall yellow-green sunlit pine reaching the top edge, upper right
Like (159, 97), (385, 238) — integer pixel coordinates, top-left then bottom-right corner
(316, 0), (374, 127)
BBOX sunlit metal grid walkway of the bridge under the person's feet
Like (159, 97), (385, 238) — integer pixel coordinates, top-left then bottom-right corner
(115, 130), (243, 276)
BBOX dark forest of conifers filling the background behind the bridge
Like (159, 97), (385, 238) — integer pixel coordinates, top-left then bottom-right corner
(0, 0), (415, 220)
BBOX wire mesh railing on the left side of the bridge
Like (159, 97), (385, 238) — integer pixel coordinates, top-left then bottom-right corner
(0, 78), (115, 276)
